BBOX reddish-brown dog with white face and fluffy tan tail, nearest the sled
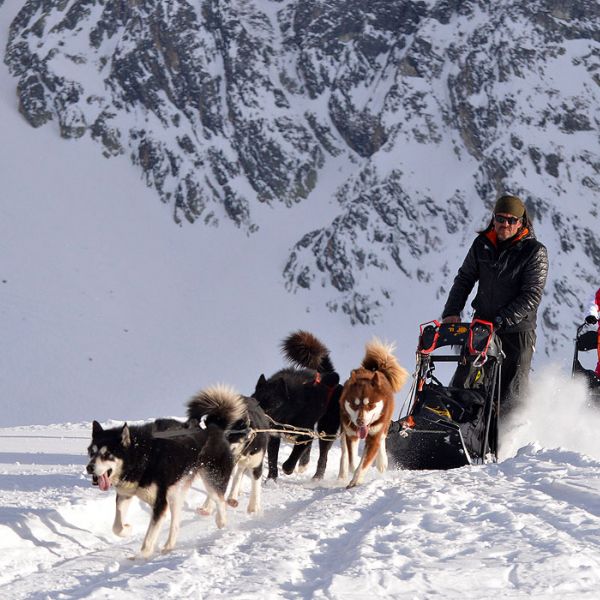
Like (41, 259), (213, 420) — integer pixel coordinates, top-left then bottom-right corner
(339, 338), (408, 488)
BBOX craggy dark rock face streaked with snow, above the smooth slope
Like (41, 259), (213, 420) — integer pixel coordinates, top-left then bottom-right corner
(5, 0), (600, 354)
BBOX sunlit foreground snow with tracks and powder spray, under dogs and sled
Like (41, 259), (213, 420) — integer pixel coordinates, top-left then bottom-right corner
(0, 369), (600, 600)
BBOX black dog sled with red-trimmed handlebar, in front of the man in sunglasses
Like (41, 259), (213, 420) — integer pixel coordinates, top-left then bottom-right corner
(386, 320), (503, 469)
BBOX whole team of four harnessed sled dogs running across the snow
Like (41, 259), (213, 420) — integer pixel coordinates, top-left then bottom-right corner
(87, 331), (408, 557)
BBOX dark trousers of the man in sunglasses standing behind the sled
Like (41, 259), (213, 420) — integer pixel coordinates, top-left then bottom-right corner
(498, 330), (537, 419)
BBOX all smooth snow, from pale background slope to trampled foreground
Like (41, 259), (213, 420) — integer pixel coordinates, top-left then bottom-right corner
(0, 0), (600, 600)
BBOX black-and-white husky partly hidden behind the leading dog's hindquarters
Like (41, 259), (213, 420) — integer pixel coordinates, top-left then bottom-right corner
(187, 385), (270, 515)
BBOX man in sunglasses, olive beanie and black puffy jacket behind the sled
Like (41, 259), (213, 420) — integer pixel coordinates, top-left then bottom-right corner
(442, 195), (548, 416)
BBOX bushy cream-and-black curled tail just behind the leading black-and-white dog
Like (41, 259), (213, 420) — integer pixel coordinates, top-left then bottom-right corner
(187, 384), (246, 429)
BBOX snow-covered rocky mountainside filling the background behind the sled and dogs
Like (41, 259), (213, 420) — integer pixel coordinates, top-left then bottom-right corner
(0, 0), (600, 424)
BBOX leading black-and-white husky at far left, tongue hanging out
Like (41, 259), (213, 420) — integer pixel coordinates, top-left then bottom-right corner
(87, 396), (244, 557)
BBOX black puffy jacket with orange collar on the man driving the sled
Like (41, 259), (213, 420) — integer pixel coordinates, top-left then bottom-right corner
(442, 228), (548, 332)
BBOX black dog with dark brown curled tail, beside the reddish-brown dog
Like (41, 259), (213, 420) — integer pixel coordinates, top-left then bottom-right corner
(253, 331), (342, 479)
